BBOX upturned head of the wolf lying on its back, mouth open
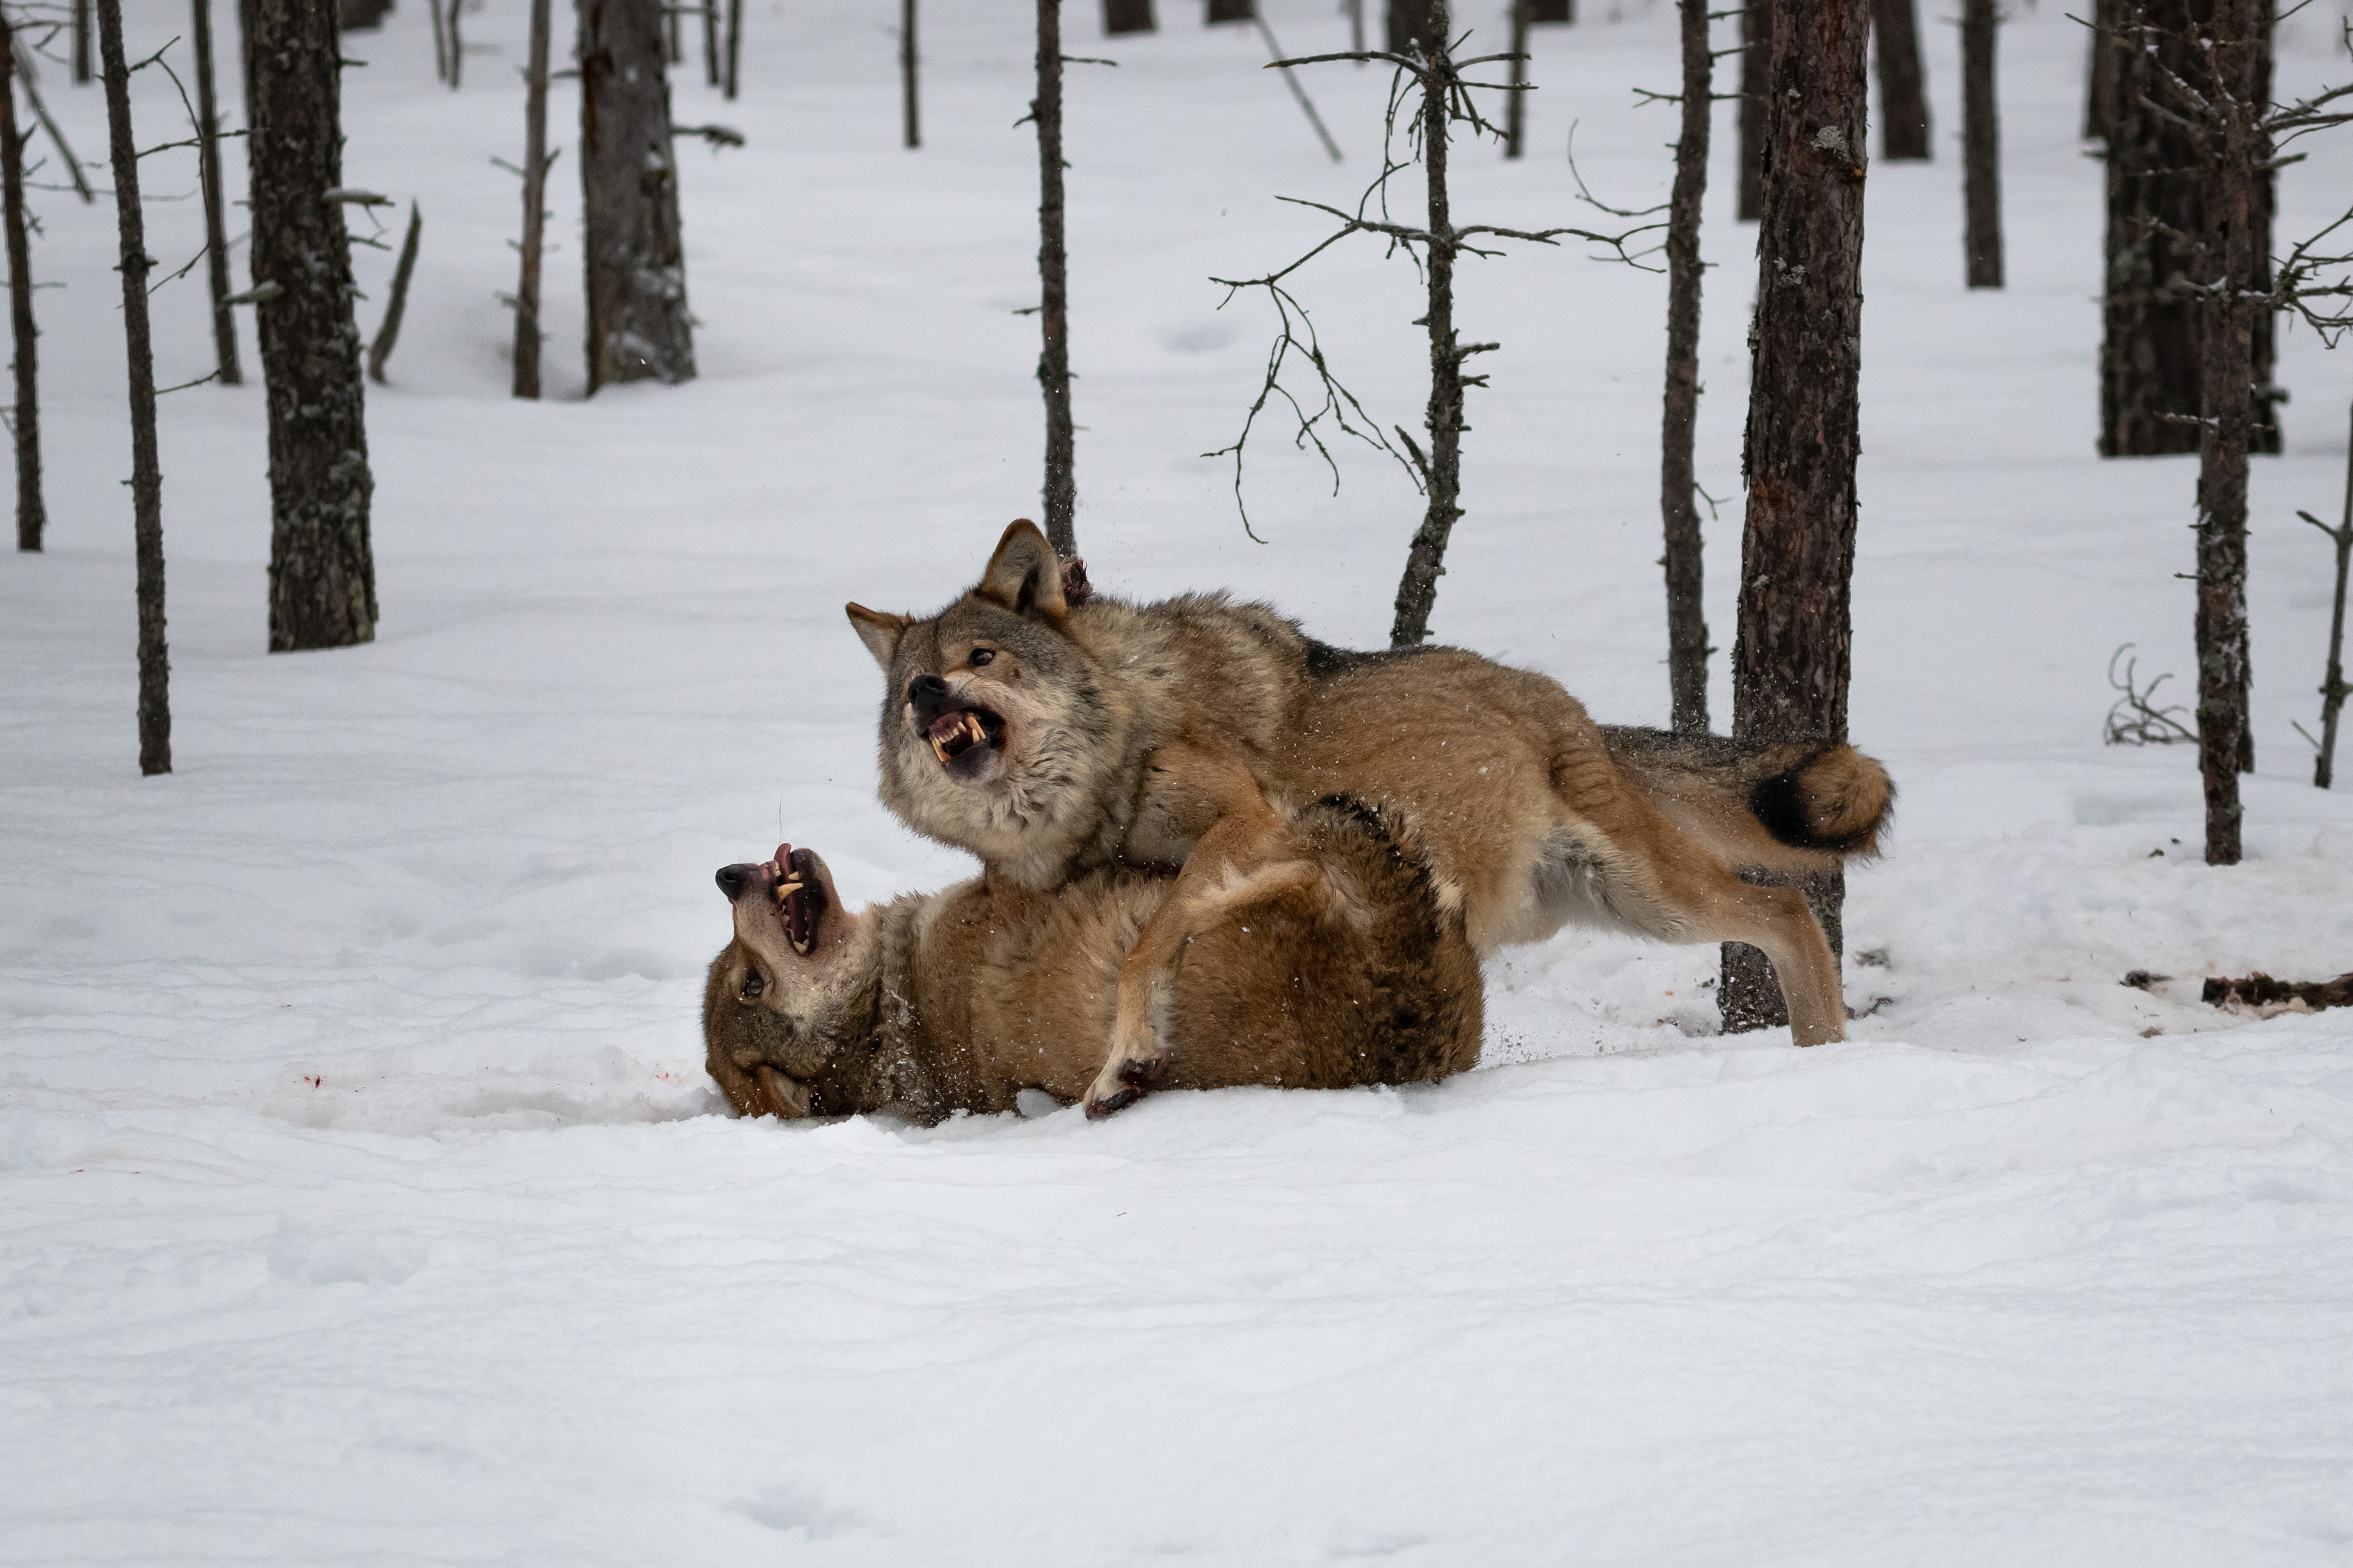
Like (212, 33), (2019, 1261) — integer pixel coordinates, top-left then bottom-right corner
(704, 844), (875, 1116)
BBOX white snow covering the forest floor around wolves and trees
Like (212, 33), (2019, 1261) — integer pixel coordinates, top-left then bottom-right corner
(0, 0), (2353, 1568)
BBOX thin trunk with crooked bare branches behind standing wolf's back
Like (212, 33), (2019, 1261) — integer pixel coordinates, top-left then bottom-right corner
(1388, 0), (1459, 649)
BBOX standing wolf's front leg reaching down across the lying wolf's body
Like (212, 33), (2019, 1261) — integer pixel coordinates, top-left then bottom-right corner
(1087, 743), (1283, 1116)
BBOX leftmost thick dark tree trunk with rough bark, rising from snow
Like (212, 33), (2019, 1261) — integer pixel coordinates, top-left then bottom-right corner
(248, 0), (376, 653)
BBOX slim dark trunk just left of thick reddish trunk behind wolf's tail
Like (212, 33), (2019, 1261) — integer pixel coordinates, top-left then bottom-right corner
(1659, 0), (1716, 736)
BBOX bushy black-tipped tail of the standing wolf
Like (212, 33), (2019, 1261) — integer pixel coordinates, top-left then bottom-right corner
(1603, 724), (1897, 860)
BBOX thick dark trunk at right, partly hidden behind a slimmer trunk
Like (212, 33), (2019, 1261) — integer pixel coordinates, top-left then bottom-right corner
(2099, 0), (2280, 458)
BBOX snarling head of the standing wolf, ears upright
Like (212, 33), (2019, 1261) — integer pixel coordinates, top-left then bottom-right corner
(847, 520), (1123, 882)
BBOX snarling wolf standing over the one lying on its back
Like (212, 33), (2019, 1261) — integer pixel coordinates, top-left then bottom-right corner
(847, 522), (1895, 1114)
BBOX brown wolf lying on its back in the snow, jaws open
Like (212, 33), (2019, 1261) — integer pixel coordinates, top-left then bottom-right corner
(704, 799), (1482, 1124)
